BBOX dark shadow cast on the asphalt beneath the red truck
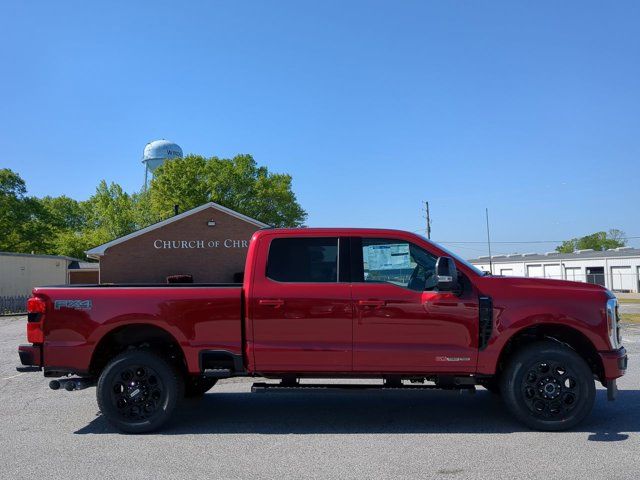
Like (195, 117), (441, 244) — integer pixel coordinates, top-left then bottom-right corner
(75, 388), (640, 442)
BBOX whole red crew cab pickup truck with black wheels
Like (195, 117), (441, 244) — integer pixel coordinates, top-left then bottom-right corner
(18, 228), (627, 432)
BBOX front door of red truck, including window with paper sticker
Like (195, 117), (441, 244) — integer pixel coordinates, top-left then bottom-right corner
(351, 238), (478, 373)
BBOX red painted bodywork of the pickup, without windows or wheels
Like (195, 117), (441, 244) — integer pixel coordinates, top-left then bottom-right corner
(23, 229), (624, 379)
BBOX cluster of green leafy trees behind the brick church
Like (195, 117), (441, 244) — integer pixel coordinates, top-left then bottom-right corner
(0, 155), (307, 258)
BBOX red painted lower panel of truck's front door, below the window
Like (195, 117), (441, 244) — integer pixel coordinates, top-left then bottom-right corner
(353, 284), (478, 373)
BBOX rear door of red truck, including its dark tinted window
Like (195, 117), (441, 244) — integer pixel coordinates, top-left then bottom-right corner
(249, 235), (353, 372)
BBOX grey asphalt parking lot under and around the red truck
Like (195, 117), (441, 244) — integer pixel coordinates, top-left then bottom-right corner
(0, 317), (640, 480)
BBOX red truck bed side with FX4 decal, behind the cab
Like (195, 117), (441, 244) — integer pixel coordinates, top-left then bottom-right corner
(34, 284), (243, 373)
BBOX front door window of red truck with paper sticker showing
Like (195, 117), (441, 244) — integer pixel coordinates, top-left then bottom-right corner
(362, 238), (437, 291)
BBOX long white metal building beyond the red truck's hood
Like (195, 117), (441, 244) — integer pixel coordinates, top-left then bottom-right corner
(469, 247), (640, 293)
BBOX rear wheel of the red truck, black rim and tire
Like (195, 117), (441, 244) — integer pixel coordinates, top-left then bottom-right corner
(96, 350), (184, 433)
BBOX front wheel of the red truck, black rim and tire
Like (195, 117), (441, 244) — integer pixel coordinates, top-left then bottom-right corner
(500, 341), (595, 431)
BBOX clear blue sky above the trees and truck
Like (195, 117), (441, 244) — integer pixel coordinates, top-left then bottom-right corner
(0, 0), (640, 257)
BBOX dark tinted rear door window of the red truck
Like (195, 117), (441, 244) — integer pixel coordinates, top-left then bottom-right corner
(267, 238), (338, 282)
